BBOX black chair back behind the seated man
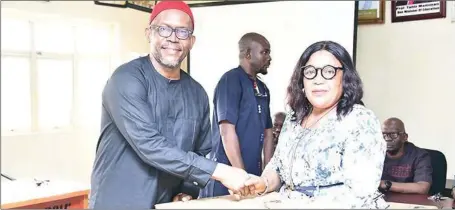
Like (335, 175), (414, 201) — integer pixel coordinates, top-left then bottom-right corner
(425, 149), (447, 195)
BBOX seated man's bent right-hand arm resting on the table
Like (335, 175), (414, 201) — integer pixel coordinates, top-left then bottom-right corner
(381, 152), (433, 194)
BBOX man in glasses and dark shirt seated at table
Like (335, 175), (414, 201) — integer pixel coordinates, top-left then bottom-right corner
(379, 118), (433, 194)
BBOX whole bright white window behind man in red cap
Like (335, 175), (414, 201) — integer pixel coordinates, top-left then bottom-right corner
(1, 18), (115, 134)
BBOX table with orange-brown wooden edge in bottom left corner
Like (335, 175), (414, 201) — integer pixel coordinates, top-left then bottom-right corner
(1, 180), (90, 209)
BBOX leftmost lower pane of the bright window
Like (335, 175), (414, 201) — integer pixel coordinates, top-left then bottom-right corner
(1, 56), (32, 132)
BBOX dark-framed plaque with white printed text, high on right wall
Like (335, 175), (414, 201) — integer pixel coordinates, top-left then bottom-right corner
(392, 0), (447, 23)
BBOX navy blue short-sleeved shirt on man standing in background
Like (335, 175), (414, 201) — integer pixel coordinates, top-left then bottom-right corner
(201, 66), (272, 197)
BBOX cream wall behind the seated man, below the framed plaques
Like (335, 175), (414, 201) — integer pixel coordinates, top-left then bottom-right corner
(357, 1), (455, 179)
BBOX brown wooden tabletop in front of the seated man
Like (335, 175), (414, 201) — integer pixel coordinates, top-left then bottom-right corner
(385, 192), (455, 207)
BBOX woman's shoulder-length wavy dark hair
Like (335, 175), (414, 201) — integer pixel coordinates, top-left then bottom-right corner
(287, 41), (363, 122)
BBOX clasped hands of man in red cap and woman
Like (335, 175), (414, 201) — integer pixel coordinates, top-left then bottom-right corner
(173, 164), (268, 202)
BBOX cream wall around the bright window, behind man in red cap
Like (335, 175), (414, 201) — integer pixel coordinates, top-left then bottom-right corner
(1, 1), (149, 184)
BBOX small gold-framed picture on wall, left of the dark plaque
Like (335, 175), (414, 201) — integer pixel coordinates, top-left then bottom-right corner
(358, 0), (385, 24)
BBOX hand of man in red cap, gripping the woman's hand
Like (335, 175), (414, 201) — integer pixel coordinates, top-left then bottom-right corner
(212, 163), (250, 195)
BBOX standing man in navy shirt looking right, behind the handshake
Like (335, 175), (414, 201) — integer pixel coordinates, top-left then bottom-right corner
(201, 33), (273, 197)
